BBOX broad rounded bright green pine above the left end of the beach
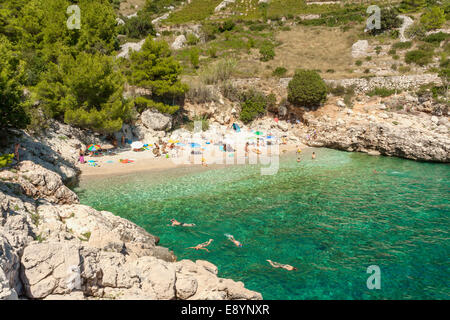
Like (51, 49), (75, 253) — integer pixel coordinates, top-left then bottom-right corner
(36, 52), (131, 133)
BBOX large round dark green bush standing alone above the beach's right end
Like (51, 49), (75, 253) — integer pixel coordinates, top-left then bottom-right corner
(288, 70), (327, 107)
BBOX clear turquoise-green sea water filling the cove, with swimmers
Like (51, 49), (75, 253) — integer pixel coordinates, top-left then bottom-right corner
(75, 149), (450, 299)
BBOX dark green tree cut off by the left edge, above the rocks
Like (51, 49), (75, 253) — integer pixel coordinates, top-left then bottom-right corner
(0, 36), (29, 131)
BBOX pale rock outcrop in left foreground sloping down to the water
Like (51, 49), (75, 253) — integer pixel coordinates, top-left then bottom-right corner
(0, 125), (262, 299)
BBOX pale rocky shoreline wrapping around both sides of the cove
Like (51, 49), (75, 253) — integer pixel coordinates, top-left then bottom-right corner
(0, 74), (450, 299)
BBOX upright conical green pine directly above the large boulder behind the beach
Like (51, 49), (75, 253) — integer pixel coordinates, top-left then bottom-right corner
(129, 36), (188, 104)
